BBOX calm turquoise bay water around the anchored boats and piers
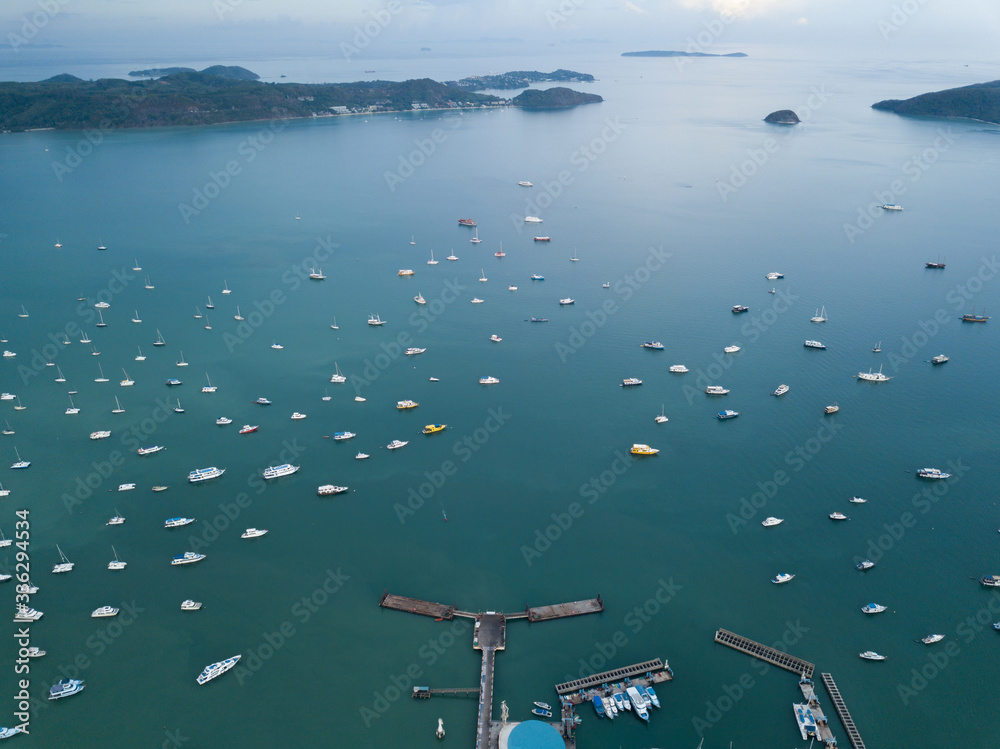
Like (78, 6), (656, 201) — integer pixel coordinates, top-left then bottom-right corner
(0, 59), (1000, 747)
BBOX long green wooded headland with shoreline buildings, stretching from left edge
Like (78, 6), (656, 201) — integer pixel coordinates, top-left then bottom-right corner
(0, 66), (603, 132)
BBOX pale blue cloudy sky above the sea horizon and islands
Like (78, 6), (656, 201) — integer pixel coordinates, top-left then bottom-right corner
(0, 0), (1000, 62)
